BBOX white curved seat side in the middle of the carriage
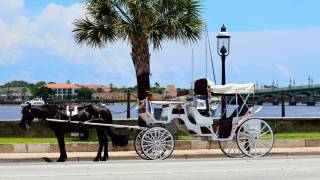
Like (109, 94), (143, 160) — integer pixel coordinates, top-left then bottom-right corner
(186, 105), (213, 125)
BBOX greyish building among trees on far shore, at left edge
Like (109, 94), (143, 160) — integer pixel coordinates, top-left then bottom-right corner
(0, 87), (32, 101)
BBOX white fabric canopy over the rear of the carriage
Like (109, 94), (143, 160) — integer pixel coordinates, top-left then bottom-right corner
(210, 83), (254, 94)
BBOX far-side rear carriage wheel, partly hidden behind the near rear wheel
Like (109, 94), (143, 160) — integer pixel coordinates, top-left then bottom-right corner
(218, 136), (245, 158)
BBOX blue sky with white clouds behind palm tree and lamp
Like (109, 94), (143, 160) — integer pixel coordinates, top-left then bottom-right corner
(0, 0), (320, 87)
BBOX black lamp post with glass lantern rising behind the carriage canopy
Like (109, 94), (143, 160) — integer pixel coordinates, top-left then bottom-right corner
(217, 25), (230, 120)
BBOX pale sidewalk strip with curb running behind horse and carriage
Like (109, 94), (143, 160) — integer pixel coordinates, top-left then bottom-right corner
(0, 147), (320, 163)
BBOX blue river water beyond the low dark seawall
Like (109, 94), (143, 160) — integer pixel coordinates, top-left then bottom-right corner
(0, 104), (320, 121)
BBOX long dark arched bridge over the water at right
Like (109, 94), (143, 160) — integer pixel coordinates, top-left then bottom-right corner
(250, 84), (320, 106)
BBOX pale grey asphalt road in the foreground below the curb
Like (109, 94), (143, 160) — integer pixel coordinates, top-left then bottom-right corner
(0, 156), (320, 180)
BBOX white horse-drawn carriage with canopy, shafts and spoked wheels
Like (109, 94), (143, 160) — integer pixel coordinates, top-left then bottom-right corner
(47, 79), (274, 160)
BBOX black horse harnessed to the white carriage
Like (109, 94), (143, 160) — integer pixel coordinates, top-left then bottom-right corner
(20, 104), (128, 162)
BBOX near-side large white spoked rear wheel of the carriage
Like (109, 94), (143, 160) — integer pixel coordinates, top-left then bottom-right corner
(237, 119), (274, 157)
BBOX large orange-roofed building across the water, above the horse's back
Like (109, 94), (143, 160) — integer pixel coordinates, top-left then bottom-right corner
(45, 84), (81, 99)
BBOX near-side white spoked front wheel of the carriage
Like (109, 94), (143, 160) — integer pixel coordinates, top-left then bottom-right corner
(141, 127), (175, 160)
